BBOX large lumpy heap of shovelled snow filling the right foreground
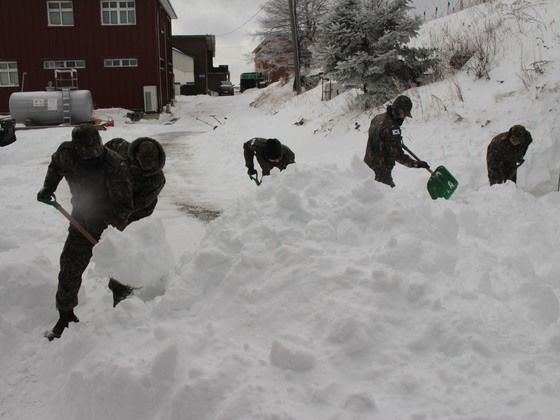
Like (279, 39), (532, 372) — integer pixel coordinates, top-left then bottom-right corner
(162, 165), (560, 419)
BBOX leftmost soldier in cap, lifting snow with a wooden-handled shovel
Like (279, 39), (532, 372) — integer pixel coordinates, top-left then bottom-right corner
(37, 125), (133, 340)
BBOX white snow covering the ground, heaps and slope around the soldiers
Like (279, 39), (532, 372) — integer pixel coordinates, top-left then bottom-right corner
(0, 0), (560, 420)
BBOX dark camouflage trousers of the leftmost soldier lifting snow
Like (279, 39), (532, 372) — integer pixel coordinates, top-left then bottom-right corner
(56, 222), (108, 311)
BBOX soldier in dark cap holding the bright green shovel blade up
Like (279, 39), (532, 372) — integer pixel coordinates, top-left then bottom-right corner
(364, 95), (429, 187)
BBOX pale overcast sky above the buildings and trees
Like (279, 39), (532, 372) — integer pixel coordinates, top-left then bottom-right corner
(171, 0), (460, 84)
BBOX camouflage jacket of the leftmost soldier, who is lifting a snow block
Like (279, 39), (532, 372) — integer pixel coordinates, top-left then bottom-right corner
(44, 141), (133, 228)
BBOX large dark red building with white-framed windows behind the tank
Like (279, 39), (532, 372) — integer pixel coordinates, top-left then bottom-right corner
(0, 0), (177, 113)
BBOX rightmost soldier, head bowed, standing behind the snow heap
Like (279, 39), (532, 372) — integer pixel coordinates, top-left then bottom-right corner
(486, 125), (533, 185)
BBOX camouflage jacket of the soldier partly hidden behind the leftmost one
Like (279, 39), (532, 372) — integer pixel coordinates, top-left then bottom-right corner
(105, 138), (165, 222)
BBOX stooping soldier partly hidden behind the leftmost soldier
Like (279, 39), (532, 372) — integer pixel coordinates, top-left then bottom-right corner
(105, 137), (165, 307)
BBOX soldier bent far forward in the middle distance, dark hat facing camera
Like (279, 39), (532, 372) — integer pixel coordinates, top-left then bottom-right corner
(243, 137), (295, 176)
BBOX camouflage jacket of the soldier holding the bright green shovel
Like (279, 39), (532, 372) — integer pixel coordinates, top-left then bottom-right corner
(364, 106), (417, 170)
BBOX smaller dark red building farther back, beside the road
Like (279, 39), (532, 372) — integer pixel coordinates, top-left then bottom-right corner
(173, 35), (229, 95)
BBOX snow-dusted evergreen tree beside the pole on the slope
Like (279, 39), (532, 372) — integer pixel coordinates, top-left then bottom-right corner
(317, 0), (434, 102)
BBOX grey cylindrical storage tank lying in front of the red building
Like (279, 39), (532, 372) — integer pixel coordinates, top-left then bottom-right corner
(9, 90), (93, 125)
